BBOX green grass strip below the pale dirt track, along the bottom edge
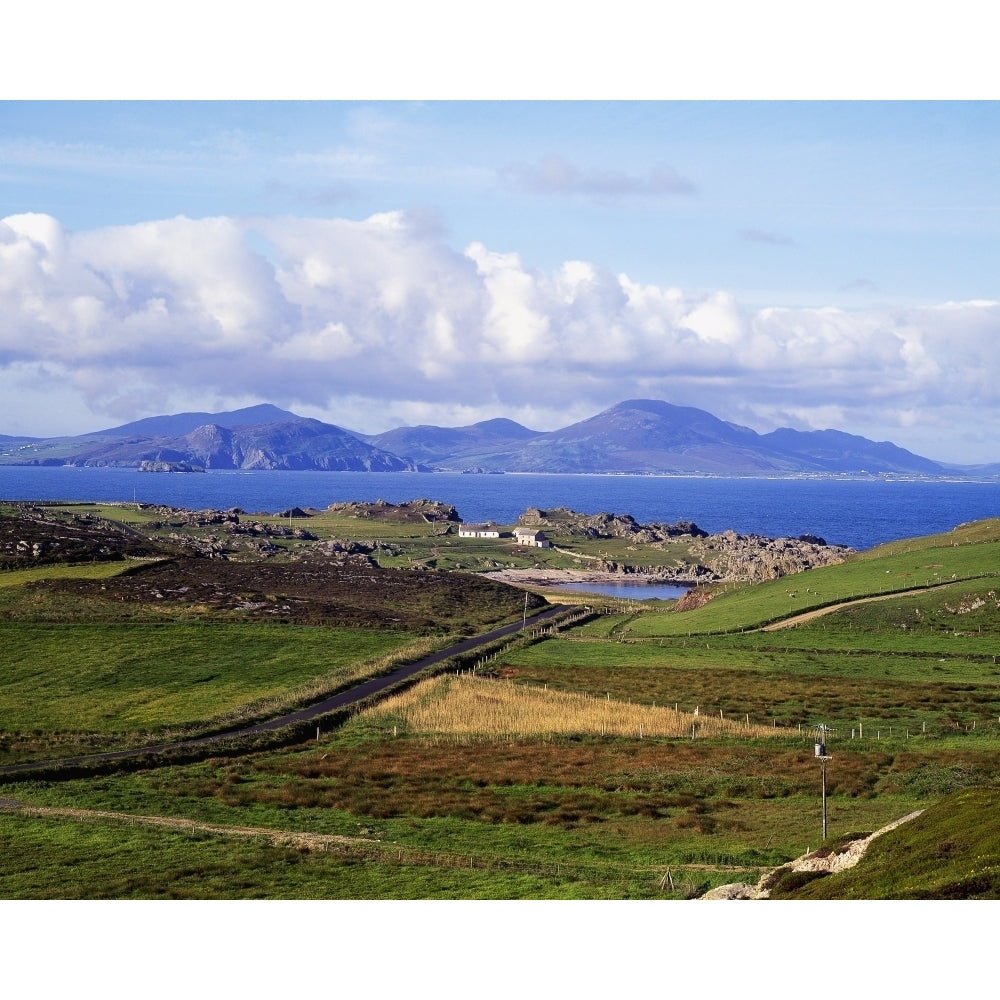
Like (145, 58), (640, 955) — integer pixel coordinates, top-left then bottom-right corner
(0, 817), (676, 900)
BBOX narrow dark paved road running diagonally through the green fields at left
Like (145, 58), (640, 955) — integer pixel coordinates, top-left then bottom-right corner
(0, 604), (569, 776)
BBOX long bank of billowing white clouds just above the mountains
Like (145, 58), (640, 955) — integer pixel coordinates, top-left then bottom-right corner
(0, 212), (1000, 461)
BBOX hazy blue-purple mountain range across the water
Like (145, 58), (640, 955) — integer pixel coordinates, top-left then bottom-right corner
(0, 399), (1000, 476)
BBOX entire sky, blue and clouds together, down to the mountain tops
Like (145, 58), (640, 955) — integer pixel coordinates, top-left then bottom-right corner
(0, 4), (1000, 464)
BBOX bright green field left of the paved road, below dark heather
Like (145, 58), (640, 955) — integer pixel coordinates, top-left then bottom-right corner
(0, 622), (409, 734)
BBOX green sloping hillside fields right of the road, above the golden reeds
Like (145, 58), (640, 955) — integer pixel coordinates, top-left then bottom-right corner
(504, 522), (1000, 739)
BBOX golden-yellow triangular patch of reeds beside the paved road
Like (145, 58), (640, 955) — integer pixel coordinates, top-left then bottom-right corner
(365, 675), (788, 739)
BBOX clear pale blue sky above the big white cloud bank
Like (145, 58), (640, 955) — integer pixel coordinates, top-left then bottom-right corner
(0, 101), (1000, 307)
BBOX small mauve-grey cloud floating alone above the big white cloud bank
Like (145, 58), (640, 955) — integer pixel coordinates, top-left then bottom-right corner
(504, 154), (697, 198)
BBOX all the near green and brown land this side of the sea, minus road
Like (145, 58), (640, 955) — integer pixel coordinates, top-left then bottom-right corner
(0, 501), (1000, 900)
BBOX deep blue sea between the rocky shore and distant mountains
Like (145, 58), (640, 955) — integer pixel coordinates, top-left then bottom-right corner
(0, 466), (1000, 549)
